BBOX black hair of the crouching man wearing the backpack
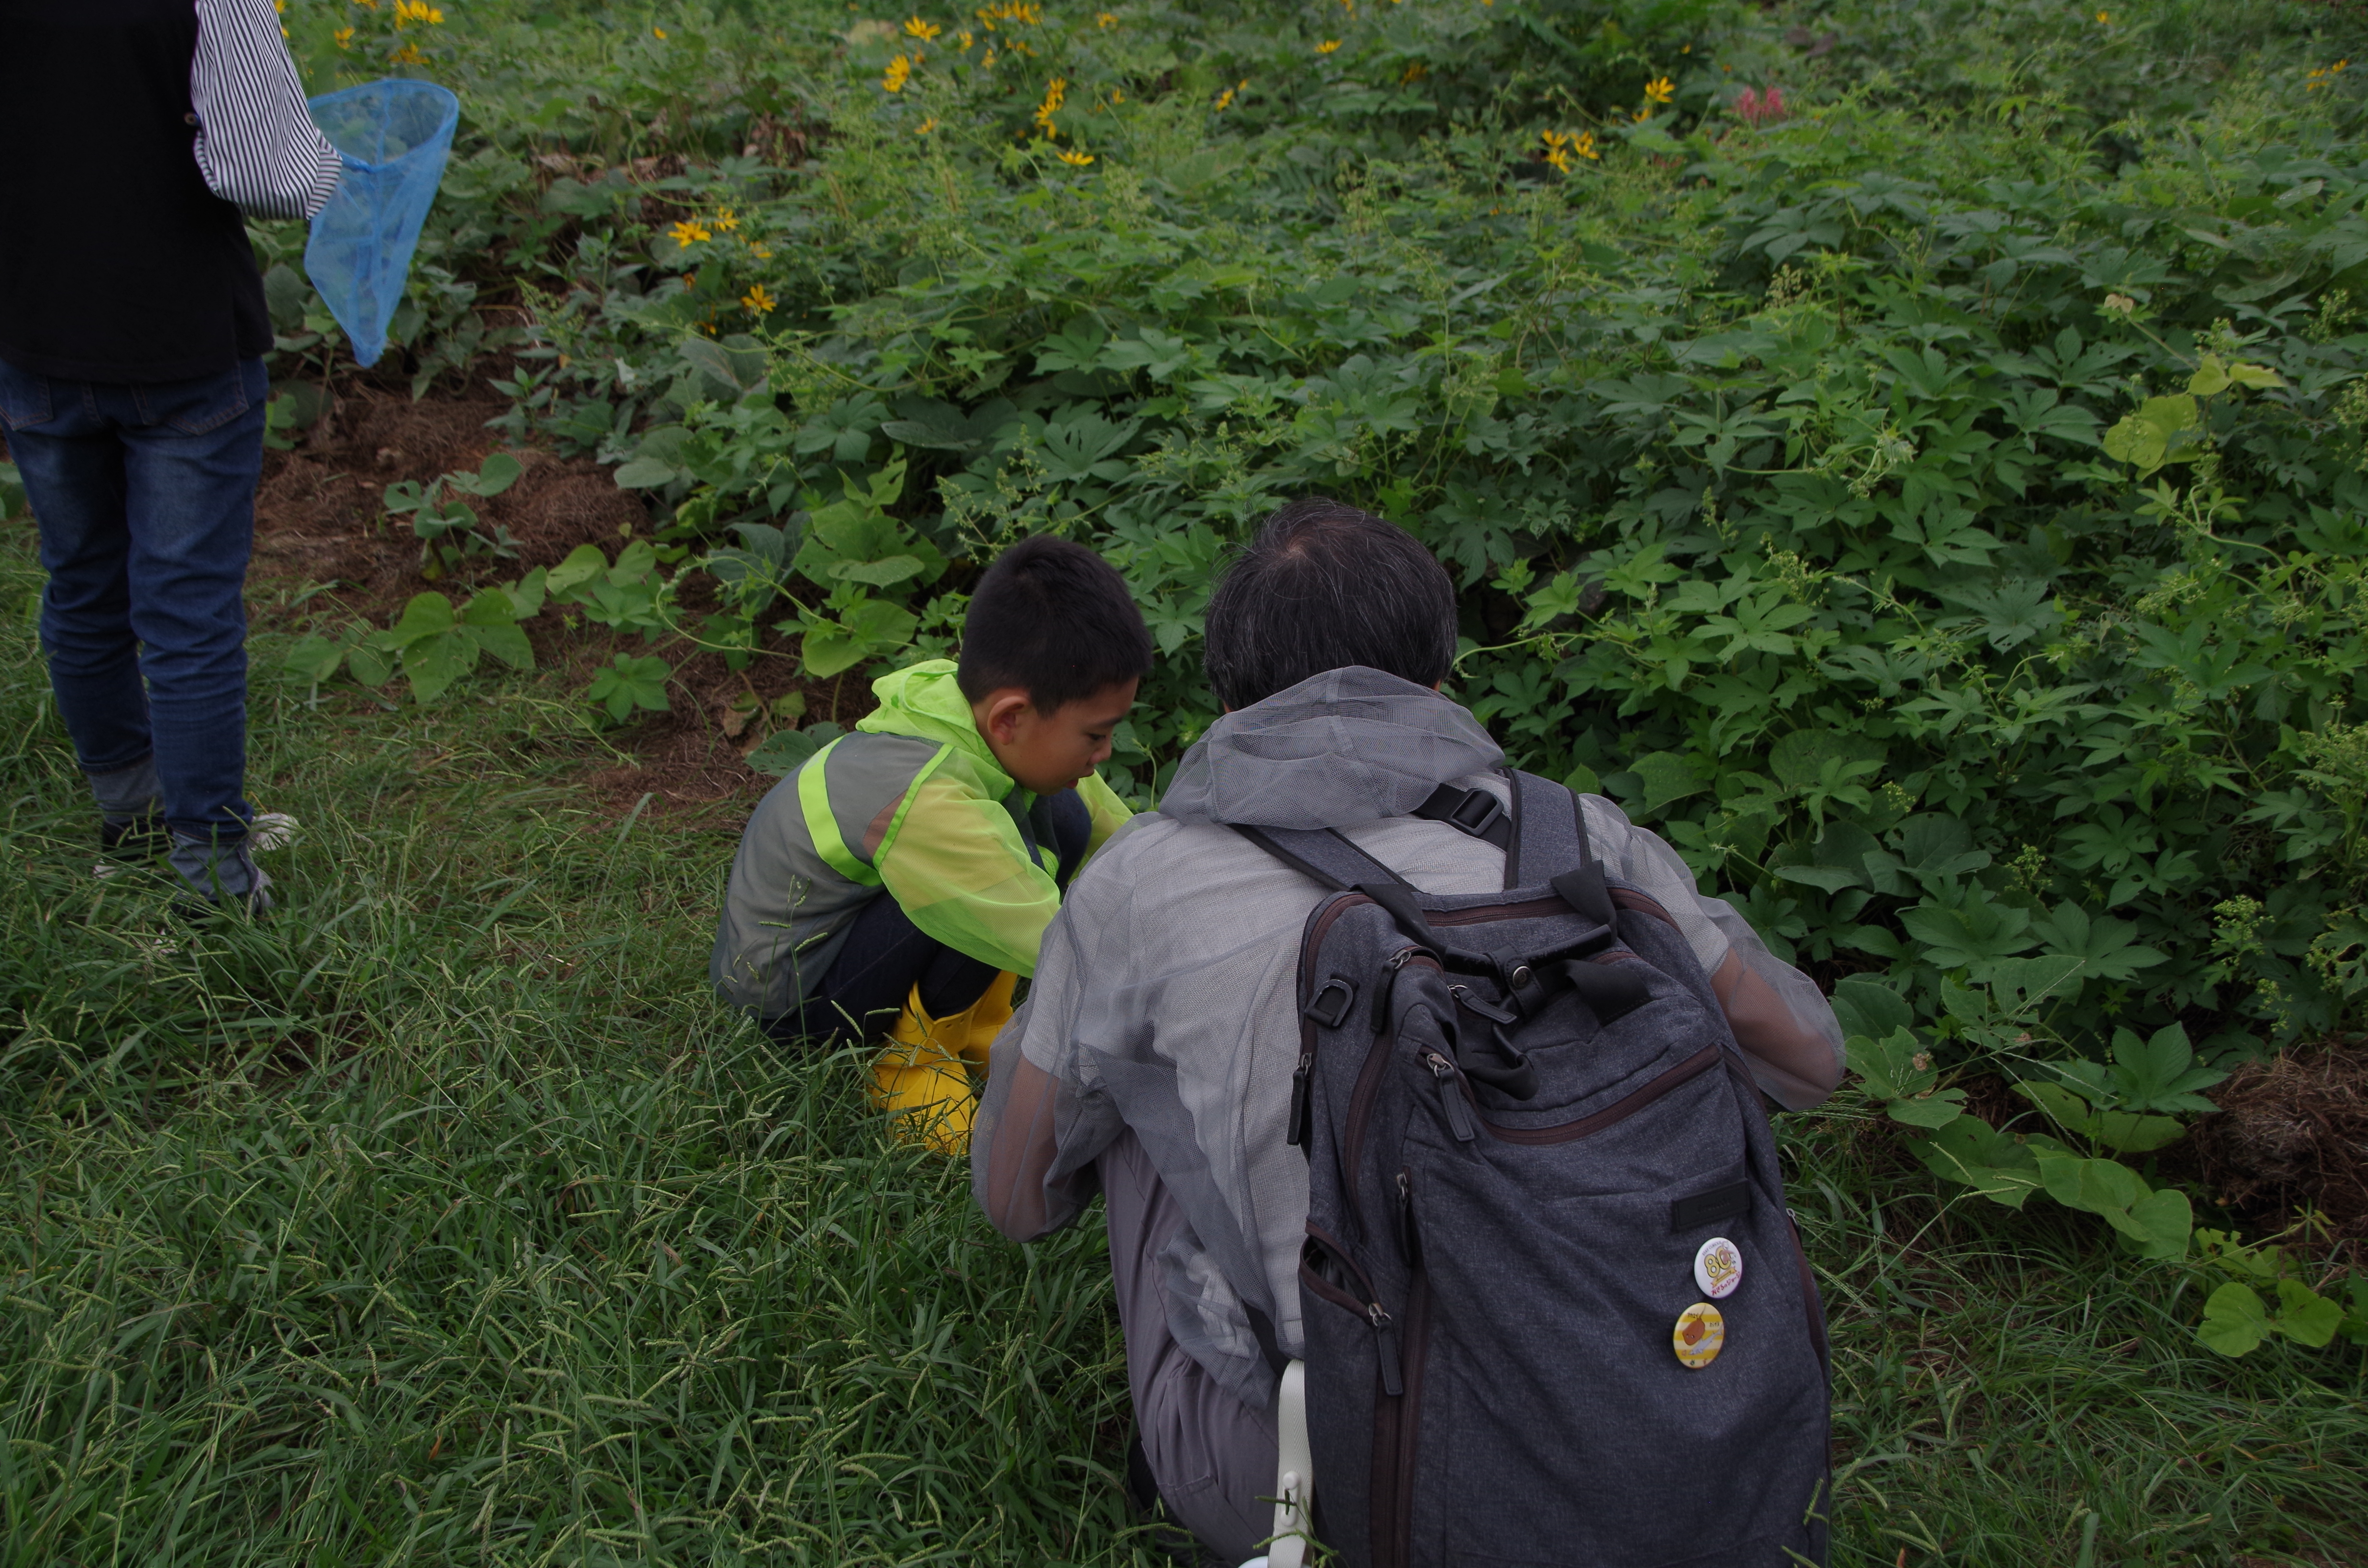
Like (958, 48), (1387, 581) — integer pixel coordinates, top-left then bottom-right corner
(1203, 495), (1456, 708)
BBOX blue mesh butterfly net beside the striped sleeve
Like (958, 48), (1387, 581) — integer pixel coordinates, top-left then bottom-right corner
(303, 81), (459, 365)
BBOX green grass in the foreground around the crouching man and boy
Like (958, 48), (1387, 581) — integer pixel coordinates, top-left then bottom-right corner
(0, 559), (2368, 1568)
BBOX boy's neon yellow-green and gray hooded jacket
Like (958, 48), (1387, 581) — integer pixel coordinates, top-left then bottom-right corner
(708, 659), (1130, 1018)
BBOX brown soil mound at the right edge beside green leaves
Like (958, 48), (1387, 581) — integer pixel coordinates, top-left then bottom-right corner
(2188, 1040), (2368, 1258)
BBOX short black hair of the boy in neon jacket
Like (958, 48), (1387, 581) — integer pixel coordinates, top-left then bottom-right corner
(954, 533), (1151, 713)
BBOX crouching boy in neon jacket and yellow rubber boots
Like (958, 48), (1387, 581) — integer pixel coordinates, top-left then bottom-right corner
(708, 538), (1151, 1153)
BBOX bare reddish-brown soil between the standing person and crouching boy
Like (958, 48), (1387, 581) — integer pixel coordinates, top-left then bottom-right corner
(251, 384), (872, 829)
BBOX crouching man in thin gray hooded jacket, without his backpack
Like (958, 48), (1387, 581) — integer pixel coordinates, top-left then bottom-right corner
(971, 500), (1842, 1563)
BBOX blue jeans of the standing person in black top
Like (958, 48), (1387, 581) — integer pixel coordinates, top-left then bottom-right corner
(0, 360), (270, 845)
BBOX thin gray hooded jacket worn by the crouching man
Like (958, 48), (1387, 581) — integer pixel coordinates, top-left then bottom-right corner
(971, 668), (1842, 1409)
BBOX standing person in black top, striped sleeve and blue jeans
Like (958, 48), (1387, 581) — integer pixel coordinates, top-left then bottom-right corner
(0, 0), (341, 912)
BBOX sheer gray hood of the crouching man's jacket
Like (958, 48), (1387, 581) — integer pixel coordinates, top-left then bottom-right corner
(1155, 665), (1504, 827)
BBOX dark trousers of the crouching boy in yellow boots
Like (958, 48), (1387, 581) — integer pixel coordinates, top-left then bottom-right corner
(765, 789), (1094, 1044)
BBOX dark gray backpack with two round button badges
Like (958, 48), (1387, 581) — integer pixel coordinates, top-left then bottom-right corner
(1238, 774), (1828, 1568)
